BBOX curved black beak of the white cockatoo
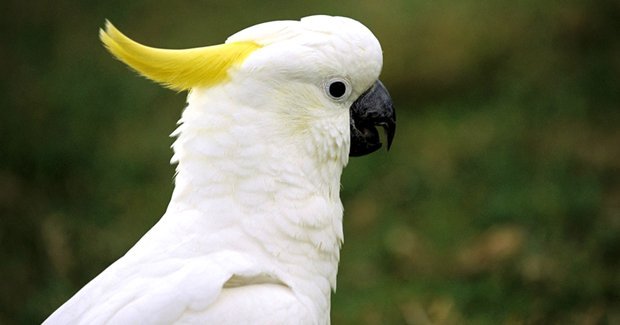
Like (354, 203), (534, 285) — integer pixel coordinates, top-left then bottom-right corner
(349, 80), (396, 157)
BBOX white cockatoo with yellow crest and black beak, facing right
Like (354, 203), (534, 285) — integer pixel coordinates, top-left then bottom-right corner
(45, 16), (396, 325)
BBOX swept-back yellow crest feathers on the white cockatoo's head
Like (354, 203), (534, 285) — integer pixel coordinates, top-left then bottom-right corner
(99, 21), (260, 91)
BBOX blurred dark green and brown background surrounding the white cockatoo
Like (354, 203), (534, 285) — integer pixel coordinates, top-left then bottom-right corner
(0, 0), (620, 324)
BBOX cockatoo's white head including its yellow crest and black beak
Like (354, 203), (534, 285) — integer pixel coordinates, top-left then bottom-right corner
(100, 16), (396, 160)
